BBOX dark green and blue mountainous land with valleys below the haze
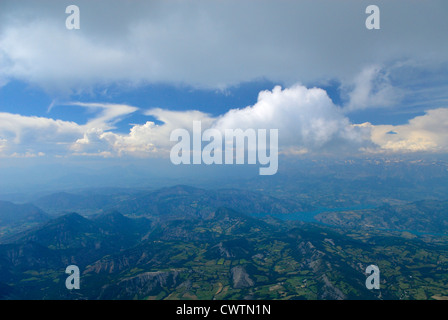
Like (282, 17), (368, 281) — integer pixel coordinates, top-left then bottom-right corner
(0, 185), (448, 300)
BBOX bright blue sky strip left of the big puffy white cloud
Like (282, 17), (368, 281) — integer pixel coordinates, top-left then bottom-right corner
(0, 80), (280, 133)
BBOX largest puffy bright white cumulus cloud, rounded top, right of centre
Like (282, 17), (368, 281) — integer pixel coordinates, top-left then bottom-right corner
(215, 85), (372, 150)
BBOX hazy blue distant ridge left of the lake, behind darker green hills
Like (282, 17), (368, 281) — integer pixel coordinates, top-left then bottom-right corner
(32, 185), (314, 218)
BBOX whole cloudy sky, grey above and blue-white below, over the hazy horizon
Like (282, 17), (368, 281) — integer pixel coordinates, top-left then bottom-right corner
(0, 0), (448, 192)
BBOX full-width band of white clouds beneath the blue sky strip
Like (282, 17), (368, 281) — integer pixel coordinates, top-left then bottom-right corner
(0, 85), (448, 157)
